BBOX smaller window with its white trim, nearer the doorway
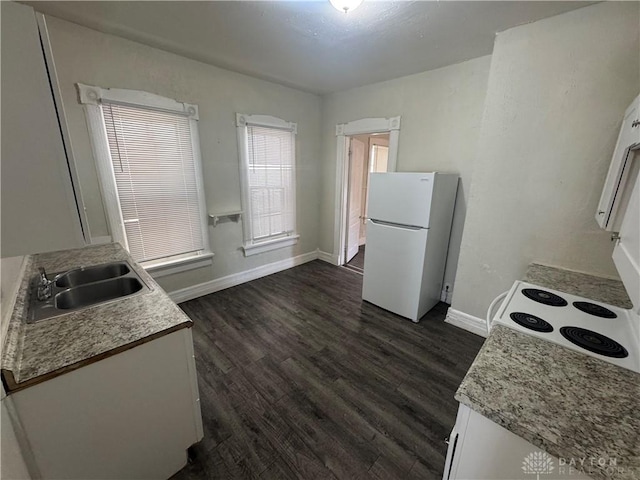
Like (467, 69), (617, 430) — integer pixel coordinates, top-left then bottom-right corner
(236, 114), (299, 256)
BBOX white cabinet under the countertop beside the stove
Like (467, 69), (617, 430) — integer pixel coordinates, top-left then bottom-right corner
(443, 405), (593, 480)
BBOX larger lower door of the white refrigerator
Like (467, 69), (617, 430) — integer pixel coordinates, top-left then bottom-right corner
(362, 220), (429, 322)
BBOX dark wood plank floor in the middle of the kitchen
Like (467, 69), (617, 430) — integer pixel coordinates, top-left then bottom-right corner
(173, 261), (482, 480)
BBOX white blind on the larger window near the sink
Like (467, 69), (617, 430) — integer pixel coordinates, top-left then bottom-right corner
(102, 104), (204, 262)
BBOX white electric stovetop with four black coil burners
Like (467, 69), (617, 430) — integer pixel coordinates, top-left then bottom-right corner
(492, 281), (640, 373)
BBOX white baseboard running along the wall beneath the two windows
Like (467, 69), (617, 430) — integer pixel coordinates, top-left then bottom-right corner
(169, 250), (318, 303)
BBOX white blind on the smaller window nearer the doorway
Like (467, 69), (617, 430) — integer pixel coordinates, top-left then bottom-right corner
(247, 125), (295, 242)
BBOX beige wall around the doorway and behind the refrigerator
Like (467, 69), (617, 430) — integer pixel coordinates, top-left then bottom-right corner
(320, 56), (490, 284)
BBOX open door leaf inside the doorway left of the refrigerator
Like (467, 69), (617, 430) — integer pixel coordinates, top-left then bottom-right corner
(345, 138), (365, 262)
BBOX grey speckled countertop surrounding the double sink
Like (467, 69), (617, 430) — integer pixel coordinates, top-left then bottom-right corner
(1, 244), (193, 392)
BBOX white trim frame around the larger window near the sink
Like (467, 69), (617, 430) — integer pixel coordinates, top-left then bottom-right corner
(76, 83), (213, 270)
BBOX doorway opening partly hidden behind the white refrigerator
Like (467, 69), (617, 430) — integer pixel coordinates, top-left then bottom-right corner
(344, 132), (389, 273)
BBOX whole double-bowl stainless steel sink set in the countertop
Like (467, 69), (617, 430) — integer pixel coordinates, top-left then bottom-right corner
(27, 261), (151, 323)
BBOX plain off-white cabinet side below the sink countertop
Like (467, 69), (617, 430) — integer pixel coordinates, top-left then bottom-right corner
(6, 328), (203, 480)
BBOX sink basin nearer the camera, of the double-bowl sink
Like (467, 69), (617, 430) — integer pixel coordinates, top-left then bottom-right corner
(55, 277), (142, 310)
